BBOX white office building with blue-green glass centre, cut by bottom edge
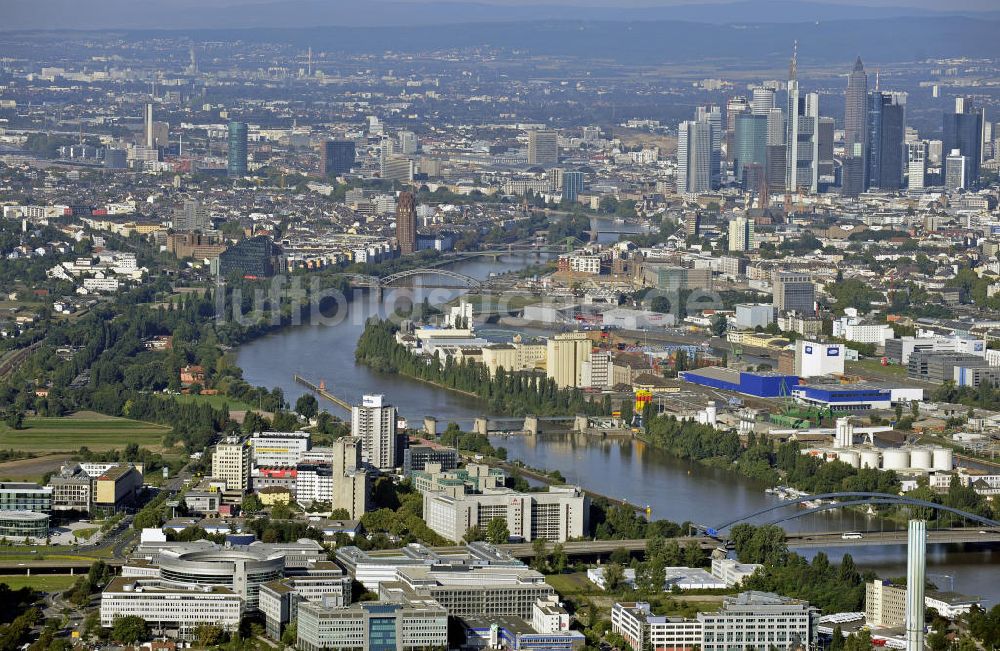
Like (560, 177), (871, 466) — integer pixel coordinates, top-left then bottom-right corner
(295, 599), (449, 651)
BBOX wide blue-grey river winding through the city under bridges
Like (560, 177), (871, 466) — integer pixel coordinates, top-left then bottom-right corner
(237, 255), (1000, 604)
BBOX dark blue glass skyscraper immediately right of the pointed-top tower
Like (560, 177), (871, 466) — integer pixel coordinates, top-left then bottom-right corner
(867, 91), (906, 190)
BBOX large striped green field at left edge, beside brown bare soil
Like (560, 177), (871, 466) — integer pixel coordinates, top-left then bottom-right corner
(0, 412), (170, 453)
